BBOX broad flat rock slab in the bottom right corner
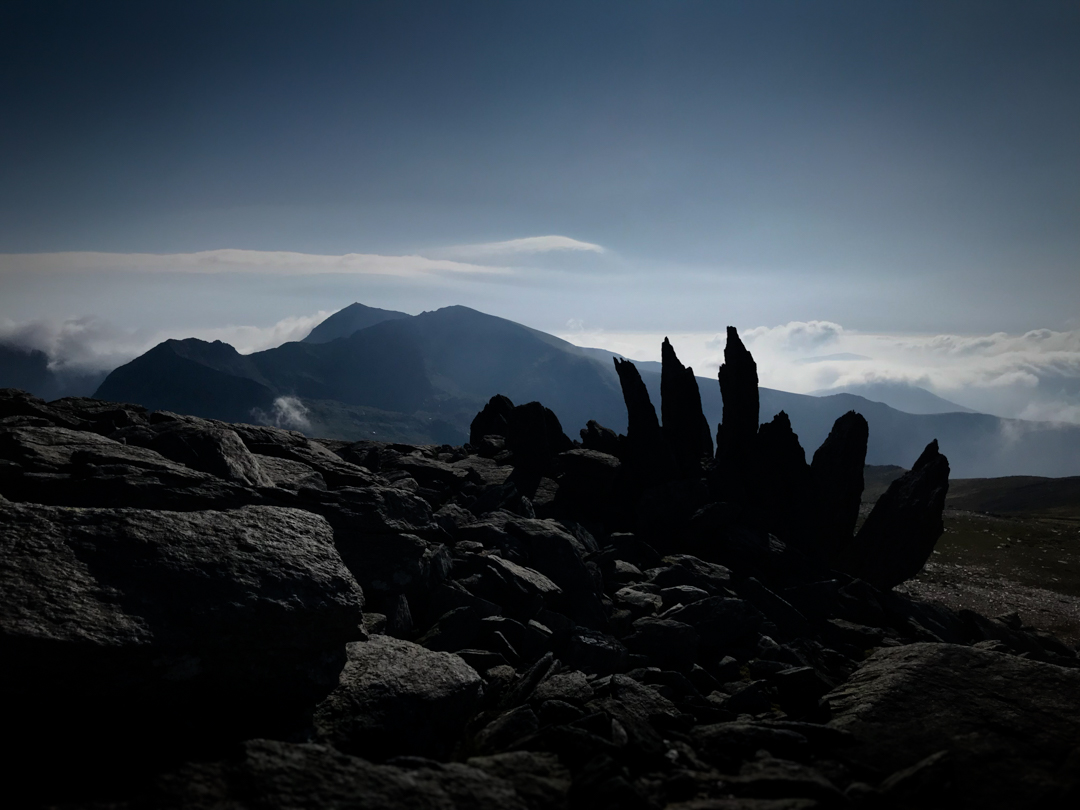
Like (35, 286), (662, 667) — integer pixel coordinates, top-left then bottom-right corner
(826, 644), (1080, 808)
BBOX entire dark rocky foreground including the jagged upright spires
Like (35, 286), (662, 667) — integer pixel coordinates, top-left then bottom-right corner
(0, 328), (1080, 810)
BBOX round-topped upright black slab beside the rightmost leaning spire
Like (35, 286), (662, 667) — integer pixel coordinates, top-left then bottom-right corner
(810, 410), (869, 561)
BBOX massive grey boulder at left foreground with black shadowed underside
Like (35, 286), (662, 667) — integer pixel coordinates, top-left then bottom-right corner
(0, 503), (363, 740)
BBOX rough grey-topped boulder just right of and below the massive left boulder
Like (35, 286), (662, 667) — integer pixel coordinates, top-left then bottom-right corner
(314, 635), (483, 759)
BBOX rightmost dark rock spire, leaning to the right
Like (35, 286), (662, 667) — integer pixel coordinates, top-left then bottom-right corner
(837, 440), (949, 589)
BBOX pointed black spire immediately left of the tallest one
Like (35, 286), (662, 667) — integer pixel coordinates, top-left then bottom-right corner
(660, 338), (713, 475)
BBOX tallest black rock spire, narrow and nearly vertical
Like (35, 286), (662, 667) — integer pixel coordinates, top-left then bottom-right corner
(716, 326), (760, 471)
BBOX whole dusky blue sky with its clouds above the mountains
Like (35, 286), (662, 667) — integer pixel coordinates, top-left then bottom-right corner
(0, 0), (1080, 421)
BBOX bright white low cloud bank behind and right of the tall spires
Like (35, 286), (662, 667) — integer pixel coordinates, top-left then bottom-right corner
(561, 321), (1080, 423)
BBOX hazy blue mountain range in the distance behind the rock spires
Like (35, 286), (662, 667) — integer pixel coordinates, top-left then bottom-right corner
(95, 303), (1080, 477)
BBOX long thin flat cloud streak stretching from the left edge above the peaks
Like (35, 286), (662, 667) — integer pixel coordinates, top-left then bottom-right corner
(0, 248), (514, 278)
